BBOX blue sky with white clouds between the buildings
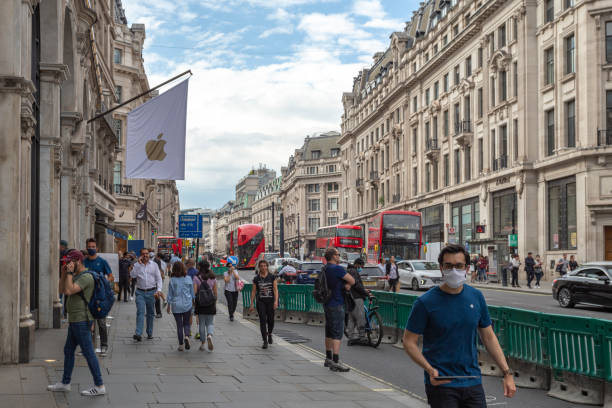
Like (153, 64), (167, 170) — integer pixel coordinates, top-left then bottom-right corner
(122, 0), (418, 209)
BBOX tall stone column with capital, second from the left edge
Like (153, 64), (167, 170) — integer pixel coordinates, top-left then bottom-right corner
(39, 63), (67, 328)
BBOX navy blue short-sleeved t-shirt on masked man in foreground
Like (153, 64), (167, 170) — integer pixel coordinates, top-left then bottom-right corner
(406, 285), (491, 387)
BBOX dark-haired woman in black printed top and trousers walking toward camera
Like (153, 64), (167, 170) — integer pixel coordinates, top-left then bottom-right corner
(249, 259), (278, 349)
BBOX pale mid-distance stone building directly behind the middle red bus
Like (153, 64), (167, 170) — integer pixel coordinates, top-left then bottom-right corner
(280, 132), (345, 255)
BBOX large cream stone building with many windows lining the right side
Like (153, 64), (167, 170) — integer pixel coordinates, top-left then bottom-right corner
(339, 0), (612, 276)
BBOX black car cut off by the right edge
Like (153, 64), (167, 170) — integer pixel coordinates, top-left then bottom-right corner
(552, 262), (612, 307)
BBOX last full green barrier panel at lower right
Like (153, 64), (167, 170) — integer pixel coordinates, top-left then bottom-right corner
(543, 315), (603, 378)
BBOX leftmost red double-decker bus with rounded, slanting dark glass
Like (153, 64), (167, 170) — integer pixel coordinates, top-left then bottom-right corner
(227, 224), (266, 268)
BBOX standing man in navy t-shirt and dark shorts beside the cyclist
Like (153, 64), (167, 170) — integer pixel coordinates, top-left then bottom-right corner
(323, 248), (355, 372)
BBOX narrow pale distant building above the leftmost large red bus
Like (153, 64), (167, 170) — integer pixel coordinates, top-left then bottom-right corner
(251, 177), (282, 252)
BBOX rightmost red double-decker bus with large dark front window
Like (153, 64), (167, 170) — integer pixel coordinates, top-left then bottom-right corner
(368, 210), (423, 263)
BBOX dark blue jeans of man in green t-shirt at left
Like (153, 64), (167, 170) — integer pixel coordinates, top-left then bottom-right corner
(62, 322), (104, 387)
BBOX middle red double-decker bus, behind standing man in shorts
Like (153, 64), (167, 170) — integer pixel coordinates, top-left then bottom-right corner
(315, 225), (363, 262)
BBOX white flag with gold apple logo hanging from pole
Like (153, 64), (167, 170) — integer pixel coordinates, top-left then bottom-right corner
(125, 79), (189, 180)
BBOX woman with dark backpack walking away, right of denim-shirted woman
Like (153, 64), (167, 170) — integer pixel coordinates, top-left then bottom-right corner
(193, 261), (217, 351)
